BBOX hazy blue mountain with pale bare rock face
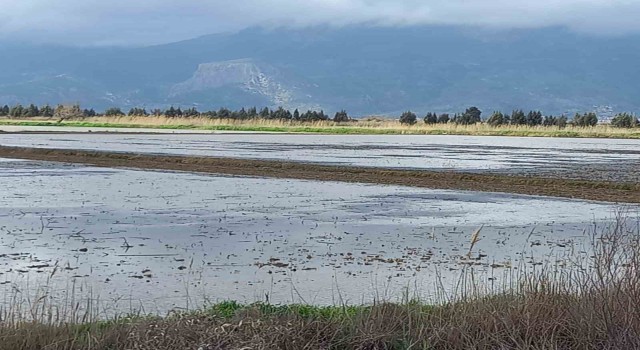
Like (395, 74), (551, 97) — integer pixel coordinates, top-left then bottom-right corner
(0, 26), (640, 115)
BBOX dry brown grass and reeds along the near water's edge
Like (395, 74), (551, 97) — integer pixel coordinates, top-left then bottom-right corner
(0, 215), (640, 350)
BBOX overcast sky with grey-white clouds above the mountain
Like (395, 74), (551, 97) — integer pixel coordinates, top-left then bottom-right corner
(0, 0), (640, 45)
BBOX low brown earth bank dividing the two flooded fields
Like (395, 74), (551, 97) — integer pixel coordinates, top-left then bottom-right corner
(0, 146), (640, 203)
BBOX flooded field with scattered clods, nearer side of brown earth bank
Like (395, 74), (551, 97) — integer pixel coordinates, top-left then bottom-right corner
(0, 159), (638, 313)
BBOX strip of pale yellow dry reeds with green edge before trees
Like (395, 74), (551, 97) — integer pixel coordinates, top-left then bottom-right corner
(0, 116), (640, 139)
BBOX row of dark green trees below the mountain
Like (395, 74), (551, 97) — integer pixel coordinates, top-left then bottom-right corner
(0, 104), (640, 128)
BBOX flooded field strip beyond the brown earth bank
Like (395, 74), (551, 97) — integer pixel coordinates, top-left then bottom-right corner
(0, 134), (640, 183)
